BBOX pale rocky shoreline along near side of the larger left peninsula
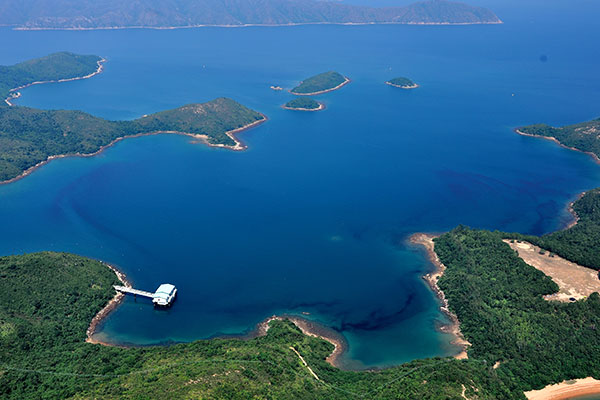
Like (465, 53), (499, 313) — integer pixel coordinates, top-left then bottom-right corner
(0, 113), (268, 185)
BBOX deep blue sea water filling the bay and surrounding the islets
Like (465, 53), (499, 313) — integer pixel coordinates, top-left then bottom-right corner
(0, 1), (600, 367)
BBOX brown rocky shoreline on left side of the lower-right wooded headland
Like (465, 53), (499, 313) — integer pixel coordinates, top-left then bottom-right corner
(409, 233), (471, 360)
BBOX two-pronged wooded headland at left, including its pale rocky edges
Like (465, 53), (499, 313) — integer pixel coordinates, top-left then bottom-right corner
(0, 53), (266, 183)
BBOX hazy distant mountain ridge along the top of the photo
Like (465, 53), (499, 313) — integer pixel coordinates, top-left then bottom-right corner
(0, 0), (502, 29)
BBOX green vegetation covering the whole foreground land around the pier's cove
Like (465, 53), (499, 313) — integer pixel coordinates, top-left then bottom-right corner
(10, 190), (600, 399)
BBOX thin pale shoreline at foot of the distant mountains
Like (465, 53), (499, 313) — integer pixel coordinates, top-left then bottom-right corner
(11, 18), (504, 31)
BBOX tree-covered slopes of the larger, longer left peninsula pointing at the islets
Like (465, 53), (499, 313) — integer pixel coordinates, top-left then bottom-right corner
(0, 98), (265, 181)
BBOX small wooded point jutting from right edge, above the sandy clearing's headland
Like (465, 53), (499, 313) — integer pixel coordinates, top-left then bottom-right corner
(518, 119), (600, 161)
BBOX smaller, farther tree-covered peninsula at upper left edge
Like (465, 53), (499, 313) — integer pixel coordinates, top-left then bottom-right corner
(0, 52), (101, 106)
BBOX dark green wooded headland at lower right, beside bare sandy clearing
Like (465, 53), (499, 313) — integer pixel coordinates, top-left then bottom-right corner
(435, 227), (600, 392)
